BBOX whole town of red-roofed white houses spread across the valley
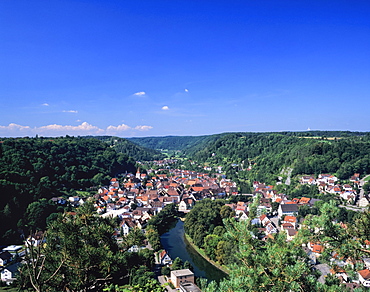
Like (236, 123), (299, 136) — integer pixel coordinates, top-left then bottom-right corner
(0, 157), (370, 291)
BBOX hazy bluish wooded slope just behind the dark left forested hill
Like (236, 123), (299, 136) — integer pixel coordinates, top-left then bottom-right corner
(86, 136), (164, 161)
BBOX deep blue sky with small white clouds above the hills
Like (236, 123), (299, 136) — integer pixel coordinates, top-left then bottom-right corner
(0, 0), (370, 137)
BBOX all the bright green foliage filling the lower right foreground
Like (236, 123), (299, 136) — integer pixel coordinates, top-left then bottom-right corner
(200, 203), (370, 292)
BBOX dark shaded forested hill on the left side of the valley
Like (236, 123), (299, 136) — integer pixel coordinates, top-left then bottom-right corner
(0, 137), (136, 245)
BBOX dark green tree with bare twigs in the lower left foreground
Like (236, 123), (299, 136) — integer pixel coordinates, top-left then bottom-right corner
(20, 203), (124, 291)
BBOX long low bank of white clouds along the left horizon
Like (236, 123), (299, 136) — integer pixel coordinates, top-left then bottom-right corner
(0, 122), (153, 137)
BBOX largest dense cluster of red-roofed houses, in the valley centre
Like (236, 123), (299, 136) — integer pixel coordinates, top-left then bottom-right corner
(87, 169), (237, 236)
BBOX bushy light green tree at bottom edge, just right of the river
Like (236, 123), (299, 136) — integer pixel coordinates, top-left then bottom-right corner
(204, 222), (341, 292)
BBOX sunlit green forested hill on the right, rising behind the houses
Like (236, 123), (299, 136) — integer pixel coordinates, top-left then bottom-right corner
(187, 132), (370, 182)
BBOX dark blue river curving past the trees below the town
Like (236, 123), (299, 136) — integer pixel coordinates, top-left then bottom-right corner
(161, 220), (226, 282)
